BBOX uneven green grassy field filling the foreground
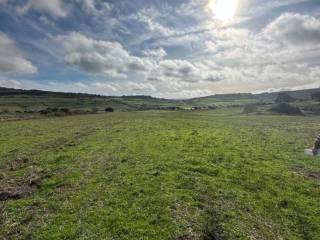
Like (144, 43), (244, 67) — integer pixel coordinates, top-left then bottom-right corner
(0, 109), (320, 240)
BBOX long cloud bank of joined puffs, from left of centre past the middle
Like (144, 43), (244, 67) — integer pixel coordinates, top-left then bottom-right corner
(57, 32), (216, 82)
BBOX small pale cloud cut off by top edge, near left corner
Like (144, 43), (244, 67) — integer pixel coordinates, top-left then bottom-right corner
(17, 0), (67, 17)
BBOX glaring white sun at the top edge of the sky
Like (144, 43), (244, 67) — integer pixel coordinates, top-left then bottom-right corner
(208, 0), (239, 21)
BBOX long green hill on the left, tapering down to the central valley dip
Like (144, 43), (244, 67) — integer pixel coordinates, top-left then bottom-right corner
(0, 87), (180, 112)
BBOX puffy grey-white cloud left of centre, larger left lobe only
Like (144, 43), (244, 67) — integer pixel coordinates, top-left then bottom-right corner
(57, 32), (150, 76)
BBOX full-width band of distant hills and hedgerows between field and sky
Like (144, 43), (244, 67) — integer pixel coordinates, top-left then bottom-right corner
(0, 88), (320, 121)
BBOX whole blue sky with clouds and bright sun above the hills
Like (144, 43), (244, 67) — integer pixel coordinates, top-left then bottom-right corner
(0, 0), (320, 98)
